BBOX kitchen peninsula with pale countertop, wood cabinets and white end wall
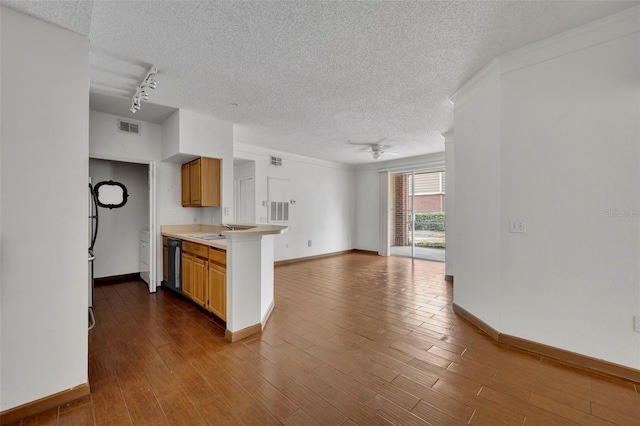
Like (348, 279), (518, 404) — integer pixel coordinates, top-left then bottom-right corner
(160, 224), (288, 341)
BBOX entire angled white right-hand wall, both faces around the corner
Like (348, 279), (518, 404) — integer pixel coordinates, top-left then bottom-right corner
(454, 8), (640, 369)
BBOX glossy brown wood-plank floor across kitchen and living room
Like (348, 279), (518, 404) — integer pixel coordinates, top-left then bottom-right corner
(7, 253), (640, 426)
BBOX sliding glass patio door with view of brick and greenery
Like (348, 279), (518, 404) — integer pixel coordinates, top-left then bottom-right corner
(389, 170), (446, 262)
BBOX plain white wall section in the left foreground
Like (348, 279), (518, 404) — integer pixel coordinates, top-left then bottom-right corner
(0, 8), (89, 410)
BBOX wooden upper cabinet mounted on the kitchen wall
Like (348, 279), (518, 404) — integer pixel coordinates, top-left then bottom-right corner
(182, 157), (220, 207)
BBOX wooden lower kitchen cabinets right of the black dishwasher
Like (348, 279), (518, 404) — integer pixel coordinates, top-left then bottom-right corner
(182, 241), (227, 321)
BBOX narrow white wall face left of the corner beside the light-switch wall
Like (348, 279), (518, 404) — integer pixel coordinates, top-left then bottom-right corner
(447, 79), (502, 328)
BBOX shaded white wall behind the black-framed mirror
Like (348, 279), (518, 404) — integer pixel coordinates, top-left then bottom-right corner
(89, 159), (149, 278)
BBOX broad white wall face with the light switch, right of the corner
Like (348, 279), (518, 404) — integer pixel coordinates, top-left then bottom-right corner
(500, 32), (640, 369)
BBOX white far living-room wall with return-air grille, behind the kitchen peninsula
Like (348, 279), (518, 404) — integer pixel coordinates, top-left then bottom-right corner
(234, 143), (355, 261)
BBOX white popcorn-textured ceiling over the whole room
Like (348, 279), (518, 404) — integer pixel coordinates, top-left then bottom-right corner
(2, 0), (640, 164)
